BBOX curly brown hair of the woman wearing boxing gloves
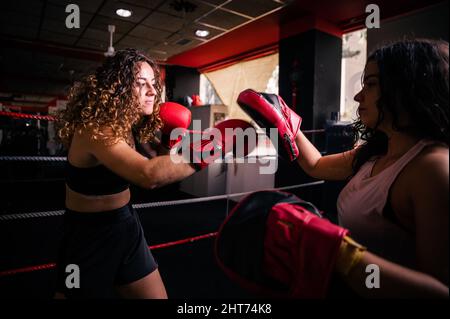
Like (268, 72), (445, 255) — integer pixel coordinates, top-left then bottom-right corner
(56, 49), (162, 147)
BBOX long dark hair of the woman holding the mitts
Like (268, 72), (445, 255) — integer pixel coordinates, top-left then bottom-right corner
(353, 39), (449, 173)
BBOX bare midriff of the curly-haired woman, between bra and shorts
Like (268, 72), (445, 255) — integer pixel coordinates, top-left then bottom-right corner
(66, 185), (130, 213)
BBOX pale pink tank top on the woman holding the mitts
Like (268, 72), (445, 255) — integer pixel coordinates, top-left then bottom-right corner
(337, 140), (435, 268)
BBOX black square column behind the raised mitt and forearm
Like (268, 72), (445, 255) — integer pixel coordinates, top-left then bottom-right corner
(275, 30), (342, 195)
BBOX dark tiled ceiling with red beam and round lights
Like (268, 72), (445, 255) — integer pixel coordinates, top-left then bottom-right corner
(0, 0), (440, 105)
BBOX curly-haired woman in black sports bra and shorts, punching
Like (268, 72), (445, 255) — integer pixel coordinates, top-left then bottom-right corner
(55, 49), (195, 299)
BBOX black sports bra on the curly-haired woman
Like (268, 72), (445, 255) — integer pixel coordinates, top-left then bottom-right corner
(66, 161), (130, 195)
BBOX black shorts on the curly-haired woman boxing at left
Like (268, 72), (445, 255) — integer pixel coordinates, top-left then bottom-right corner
(57, 205), (158, 298)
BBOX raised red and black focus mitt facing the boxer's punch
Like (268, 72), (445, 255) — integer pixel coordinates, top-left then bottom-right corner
(237, 89), (302, 161)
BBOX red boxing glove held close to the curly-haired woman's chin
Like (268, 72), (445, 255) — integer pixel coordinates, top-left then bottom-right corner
(159, 102), (192, 149)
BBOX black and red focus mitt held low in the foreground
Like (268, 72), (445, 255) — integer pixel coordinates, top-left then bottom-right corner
(215, 191), (356, 298)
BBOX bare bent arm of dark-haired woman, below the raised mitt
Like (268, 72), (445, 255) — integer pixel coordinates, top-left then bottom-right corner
(295, 131), (357, 181)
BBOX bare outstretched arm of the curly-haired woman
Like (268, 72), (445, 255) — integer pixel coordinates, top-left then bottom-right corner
(88, 136), (195, 189)
